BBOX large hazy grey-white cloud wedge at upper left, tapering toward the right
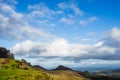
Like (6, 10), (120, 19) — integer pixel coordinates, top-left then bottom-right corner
(0, 3), (53, 40)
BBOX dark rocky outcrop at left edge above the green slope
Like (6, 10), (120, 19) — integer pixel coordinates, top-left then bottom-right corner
(0, 47), (14, 59)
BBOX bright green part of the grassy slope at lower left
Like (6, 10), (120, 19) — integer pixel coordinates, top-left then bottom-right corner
(0, 59), (50, 80)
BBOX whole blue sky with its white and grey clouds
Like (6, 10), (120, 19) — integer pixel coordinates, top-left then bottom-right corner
(0, 0), (120, 69)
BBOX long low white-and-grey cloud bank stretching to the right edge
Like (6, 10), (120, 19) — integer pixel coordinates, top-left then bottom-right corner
(11, 28), (120, 60)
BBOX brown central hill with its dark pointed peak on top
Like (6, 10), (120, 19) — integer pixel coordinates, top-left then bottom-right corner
(47, 65), (85, 80)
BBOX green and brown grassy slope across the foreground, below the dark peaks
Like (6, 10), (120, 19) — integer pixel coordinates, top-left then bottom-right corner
(0, 58), (84, 80)
